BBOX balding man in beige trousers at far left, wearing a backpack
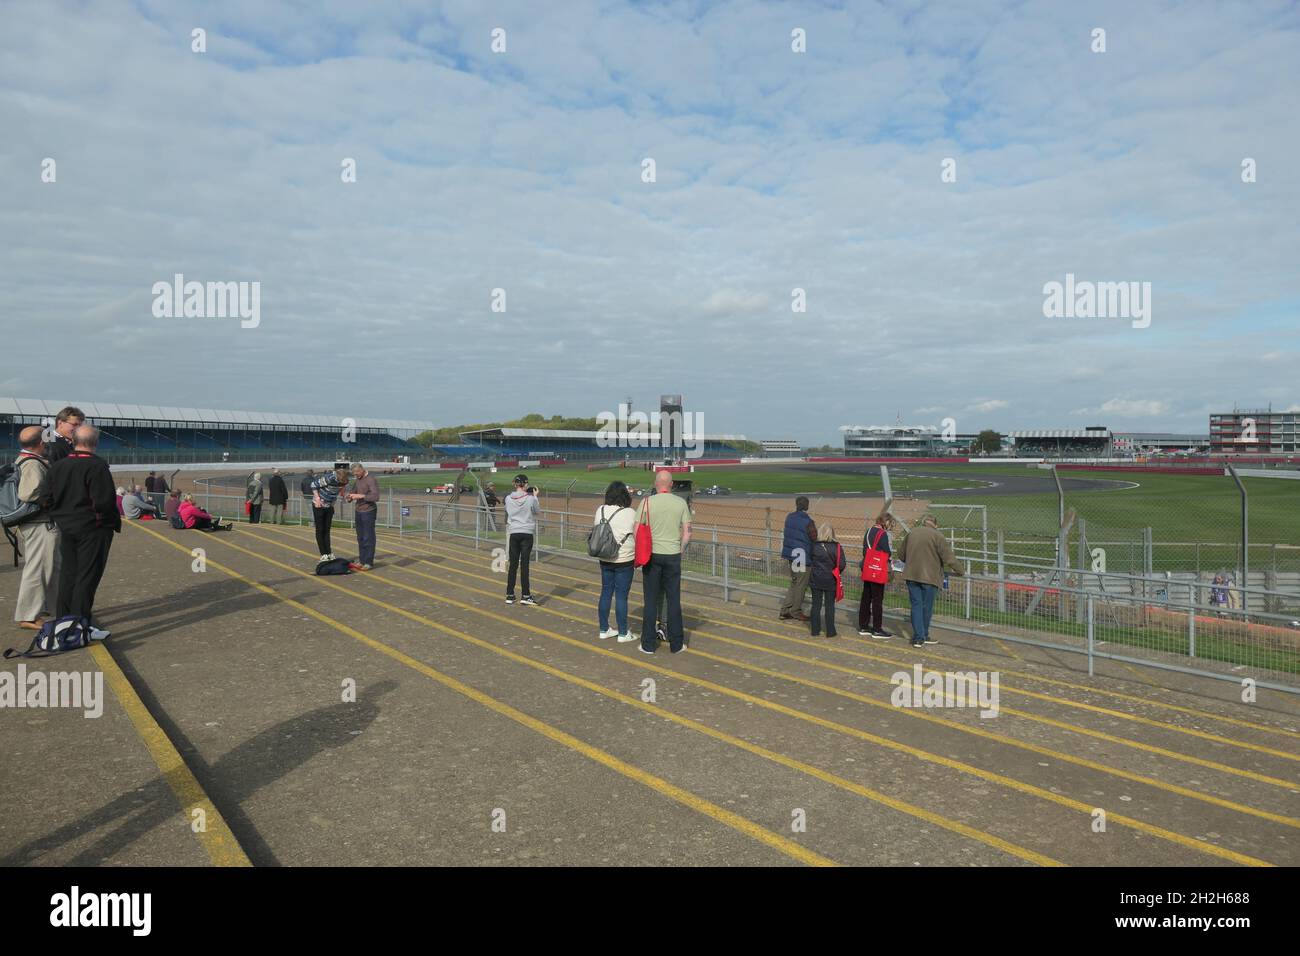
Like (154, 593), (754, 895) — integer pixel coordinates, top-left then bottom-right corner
(13, 425), (59, 631)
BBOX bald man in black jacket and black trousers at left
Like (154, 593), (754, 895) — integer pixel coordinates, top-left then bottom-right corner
(49, 424), (122, 640)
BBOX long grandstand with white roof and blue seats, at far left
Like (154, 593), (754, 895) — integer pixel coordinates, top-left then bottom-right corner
(0, 398), (433, 464)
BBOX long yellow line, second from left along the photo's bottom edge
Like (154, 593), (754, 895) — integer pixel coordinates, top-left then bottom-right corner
(129, 523), (837, 866)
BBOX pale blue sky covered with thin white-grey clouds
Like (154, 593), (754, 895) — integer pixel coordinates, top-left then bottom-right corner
(0, 0), (1300, 444)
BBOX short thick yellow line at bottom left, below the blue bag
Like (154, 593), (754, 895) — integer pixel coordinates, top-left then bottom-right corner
(90, 644), (252, 866)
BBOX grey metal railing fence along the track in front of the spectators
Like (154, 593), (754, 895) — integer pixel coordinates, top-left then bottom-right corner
(196, 492), (1300, 693)
